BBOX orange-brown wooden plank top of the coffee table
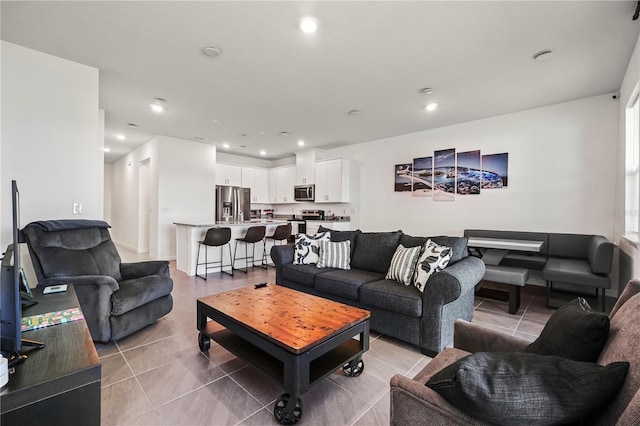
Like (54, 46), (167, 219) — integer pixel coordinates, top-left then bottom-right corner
(198, 284), (371, 353)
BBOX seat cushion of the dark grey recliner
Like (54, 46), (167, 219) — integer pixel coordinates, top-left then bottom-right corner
(111, 275), (173, 316)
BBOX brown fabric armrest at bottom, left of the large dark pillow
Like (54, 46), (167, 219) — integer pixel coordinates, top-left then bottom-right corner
(390, 374), (489, 426)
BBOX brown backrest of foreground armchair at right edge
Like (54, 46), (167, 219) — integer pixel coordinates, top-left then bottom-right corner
(595, 281), (640, 424)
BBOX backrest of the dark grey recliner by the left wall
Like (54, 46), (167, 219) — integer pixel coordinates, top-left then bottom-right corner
(23, 225), (122, 281)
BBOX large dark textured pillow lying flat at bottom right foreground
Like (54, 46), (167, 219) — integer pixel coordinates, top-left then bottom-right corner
(426, 352), (629, 426)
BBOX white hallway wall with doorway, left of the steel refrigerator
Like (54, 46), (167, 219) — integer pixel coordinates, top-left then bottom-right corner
(111, 136), (216, 259)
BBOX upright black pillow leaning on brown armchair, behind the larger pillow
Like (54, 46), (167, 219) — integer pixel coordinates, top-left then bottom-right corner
(525, 297), (609, 362)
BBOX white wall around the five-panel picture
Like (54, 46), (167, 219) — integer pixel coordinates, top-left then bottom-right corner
(325, 95), (618, 239)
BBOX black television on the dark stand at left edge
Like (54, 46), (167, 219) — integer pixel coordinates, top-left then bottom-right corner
(0, 180), (44, 366)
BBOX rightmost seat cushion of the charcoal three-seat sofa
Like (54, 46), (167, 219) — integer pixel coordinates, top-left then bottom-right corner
(360, 280), (422, 317)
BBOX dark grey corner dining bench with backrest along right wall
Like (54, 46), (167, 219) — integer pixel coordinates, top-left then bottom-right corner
(464, 229), (614, 311)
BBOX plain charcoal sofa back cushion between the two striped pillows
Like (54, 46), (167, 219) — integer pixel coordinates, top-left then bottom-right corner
(351, 231), (402, 274)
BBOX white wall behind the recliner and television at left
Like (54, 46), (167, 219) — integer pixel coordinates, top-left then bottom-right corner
(0, 41), (104, 247)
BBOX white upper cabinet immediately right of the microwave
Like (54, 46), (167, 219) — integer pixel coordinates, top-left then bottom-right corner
(316, 158), (351, 203)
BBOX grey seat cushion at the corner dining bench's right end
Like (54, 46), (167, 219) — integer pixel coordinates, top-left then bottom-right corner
(542, 257), (611, 288)
